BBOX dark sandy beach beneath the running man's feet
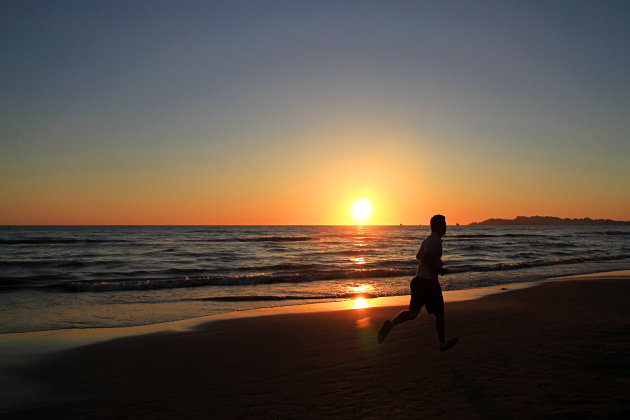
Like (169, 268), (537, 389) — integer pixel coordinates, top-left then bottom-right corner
(0, 275), (630, 418)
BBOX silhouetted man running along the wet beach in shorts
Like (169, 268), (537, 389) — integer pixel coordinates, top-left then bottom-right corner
(378, 214), (457, 351)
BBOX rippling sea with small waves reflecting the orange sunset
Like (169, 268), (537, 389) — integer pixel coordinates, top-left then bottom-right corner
(0, 225), (630, 334)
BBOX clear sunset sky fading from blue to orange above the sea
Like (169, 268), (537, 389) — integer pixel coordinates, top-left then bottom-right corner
(0, 0), (630, 225)
